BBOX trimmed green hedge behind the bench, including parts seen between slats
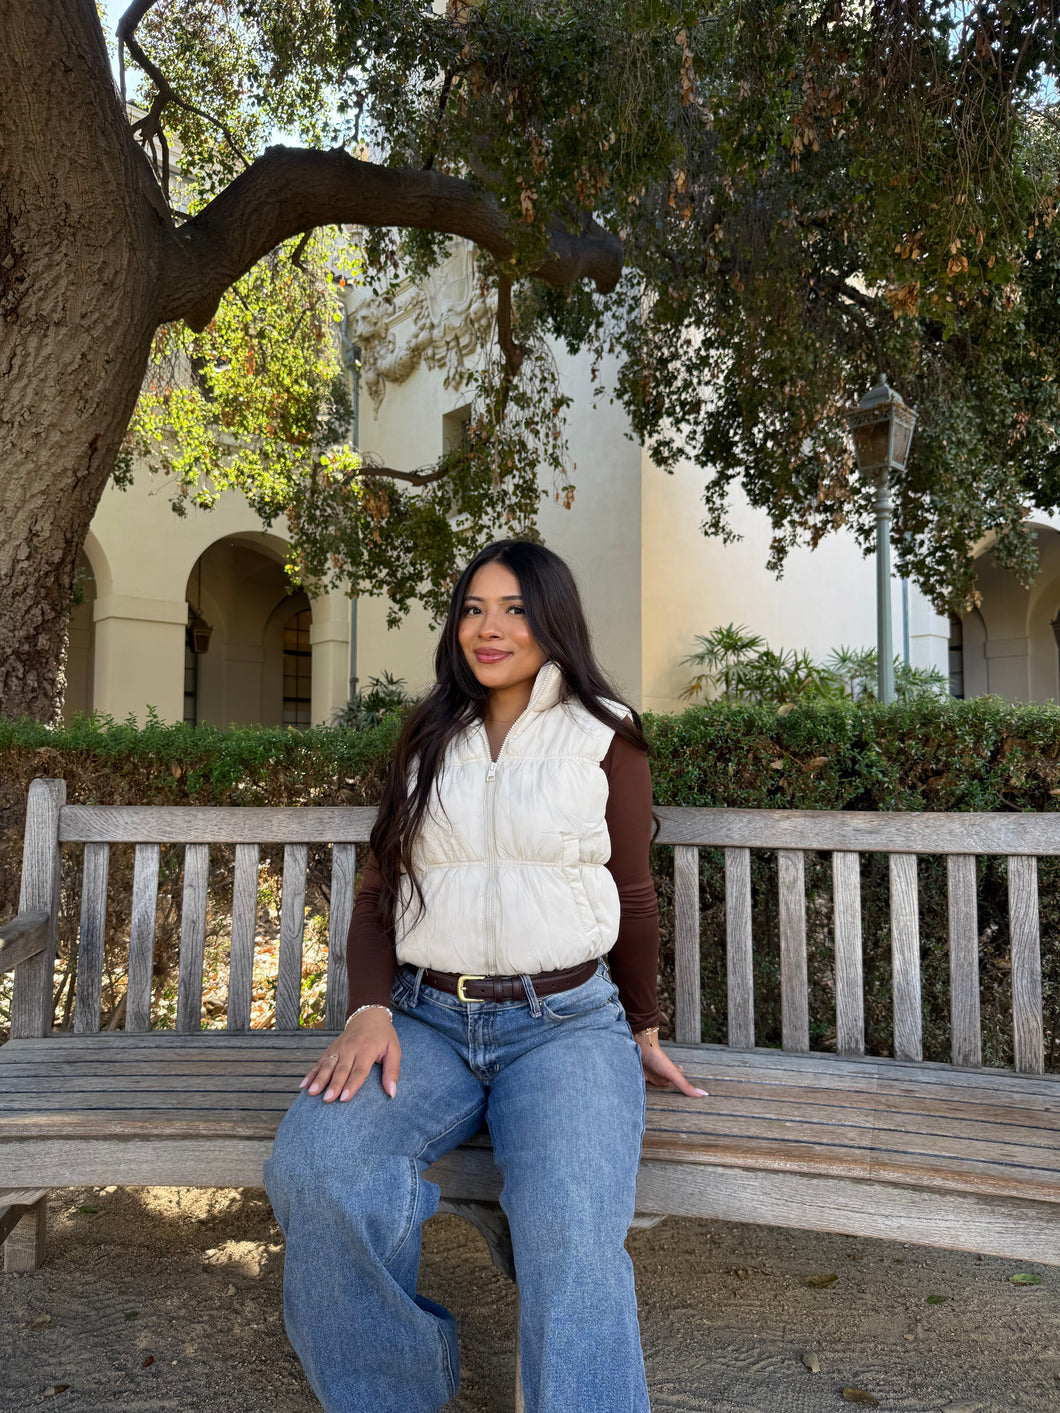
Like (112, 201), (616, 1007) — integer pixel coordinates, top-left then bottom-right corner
(0, 698), (1060, 1070)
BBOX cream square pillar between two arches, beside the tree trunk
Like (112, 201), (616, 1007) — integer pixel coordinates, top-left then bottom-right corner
(92, 593), (188, 723)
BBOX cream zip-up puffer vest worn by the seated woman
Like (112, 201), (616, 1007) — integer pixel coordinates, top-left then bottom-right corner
(397, 663), (628, 975)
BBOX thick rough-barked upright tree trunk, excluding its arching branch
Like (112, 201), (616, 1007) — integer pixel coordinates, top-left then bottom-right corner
(0, 0), (171, 721)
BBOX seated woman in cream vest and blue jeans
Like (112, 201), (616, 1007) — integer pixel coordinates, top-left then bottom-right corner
(266, 540), (702, 1413)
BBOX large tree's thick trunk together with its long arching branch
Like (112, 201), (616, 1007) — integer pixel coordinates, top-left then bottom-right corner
(0, 0), (622, 722)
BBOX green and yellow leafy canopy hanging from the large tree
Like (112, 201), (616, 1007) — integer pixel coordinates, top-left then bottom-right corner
(114, 0), (1060, 618)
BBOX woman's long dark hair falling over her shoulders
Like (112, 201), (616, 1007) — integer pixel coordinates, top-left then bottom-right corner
(370, 540), (647, 927)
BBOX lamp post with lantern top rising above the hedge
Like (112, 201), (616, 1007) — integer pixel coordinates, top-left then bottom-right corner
(847, 373), (916, 704)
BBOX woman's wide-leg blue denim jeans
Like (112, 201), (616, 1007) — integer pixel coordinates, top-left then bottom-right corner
(264, 965), (649, 1413)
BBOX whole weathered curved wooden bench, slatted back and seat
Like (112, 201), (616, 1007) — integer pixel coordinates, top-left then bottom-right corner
(0, 780), (1060, 1269)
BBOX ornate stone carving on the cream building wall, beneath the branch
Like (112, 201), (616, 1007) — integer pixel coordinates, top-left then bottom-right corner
(346, 242), (493, 411)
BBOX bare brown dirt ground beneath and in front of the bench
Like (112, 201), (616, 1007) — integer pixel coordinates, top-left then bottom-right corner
(0, 1188), (1060, 1413)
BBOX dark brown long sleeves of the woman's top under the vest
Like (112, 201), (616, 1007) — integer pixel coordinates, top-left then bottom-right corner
(346, 736), (659, 1030)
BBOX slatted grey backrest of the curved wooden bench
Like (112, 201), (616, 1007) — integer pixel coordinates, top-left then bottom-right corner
(11, 780), (1060, 1074)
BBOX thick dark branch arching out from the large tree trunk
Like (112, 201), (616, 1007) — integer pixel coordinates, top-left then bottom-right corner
(160, 147), (622, 331)
